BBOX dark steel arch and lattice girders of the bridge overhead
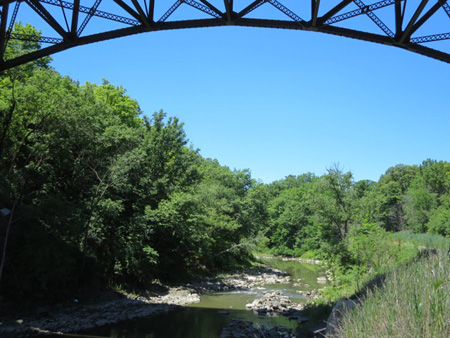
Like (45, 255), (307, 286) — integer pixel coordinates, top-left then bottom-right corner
(0, 0), (450, 71)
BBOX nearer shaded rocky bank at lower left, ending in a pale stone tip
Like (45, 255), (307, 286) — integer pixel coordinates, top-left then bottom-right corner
(0, 287), (200, 338)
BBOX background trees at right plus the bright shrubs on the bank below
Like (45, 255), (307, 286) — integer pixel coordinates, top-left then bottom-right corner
(264, 160), (450, 300)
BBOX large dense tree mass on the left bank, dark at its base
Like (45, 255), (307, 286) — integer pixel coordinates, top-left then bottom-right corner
(0, 28), (266, 300)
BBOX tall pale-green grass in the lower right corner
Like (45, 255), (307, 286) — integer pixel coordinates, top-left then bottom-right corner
(337, 251), (450, 338)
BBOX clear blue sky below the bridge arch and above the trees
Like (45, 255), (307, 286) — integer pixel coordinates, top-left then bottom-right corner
(23, 1), (450, 183)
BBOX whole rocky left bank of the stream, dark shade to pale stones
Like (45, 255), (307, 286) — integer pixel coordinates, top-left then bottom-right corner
(0, 267), (298, 338)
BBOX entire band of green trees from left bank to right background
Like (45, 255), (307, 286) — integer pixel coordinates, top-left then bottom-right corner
(0, 25), (450, 300)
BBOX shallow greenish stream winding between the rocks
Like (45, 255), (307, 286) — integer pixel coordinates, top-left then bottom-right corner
(83, 258), (325, 338)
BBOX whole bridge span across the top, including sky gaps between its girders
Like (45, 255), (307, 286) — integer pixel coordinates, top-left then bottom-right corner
(0, 0), (450, 71)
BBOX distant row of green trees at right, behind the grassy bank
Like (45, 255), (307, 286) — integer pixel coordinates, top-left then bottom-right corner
(264, 159), (450, 255)
